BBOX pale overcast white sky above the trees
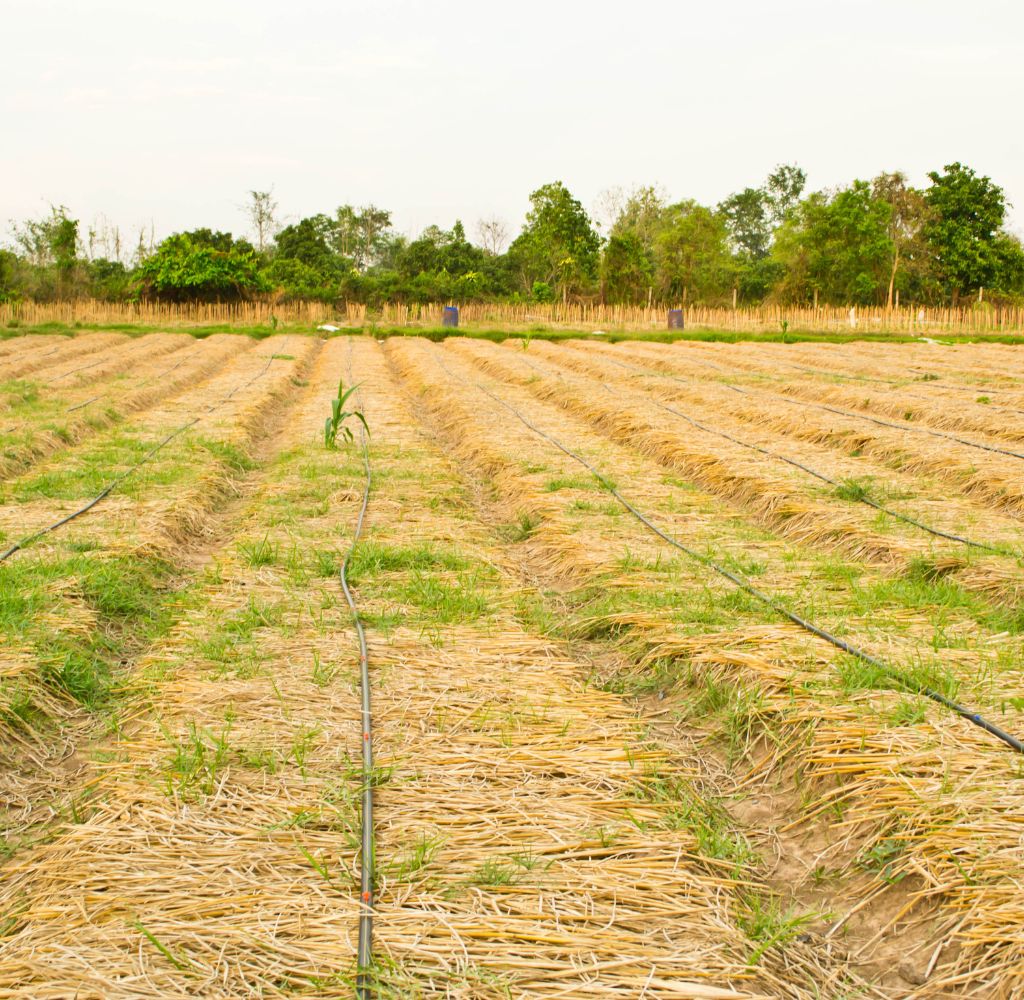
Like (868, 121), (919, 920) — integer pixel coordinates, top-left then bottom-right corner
(0, 0), (1024, 249)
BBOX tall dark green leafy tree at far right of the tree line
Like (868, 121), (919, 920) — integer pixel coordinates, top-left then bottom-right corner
(924, 163), (1007, 303)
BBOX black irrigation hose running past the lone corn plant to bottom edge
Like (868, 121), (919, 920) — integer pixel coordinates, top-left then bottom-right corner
(338, 338), (376, 1000)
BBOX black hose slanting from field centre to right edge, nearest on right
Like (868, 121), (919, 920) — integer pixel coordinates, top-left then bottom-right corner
(438, 359), (1024, 753)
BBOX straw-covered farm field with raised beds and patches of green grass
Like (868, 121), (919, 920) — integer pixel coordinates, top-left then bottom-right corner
(0, 333), (1024, 1000)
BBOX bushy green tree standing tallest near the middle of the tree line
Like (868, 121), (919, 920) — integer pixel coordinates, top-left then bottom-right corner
(509, 181), (601, 301)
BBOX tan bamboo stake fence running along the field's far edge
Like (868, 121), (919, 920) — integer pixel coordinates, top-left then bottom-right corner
(0, 300), (1024, 335)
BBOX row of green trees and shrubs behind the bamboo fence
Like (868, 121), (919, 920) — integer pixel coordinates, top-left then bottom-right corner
(0, 163), (1024, 305)
